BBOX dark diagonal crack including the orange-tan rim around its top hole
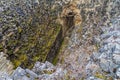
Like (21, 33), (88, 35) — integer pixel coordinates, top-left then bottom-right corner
(47, 3), (82, 62)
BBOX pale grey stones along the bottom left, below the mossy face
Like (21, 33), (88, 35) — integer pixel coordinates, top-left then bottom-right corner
(0, 61), (67, 80)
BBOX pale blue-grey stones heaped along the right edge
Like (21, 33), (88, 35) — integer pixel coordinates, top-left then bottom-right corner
(86, 16), (120, 80)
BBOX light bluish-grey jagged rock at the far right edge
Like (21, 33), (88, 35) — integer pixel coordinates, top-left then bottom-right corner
(86, 16), (120, 79)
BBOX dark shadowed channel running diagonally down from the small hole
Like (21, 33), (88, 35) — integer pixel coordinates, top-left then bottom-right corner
(46, 12), (74, 62)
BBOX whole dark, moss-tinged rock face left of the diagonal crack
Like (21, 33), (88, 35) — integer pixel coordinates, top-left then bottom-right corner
(0, 0), (62, 68)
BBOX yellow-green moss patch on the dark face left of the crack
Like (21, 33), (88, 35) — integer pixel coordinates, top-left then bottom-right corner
(7, 25), (60, 68)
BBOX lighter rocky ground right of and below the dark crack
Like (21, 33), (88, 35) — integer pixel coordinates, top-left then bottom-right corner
(0, 0), (120, 80)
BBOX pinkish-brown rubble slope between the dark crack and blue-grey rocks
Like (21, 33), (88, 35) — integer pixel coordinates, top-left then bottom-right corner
(56, 0), (120, 80)
